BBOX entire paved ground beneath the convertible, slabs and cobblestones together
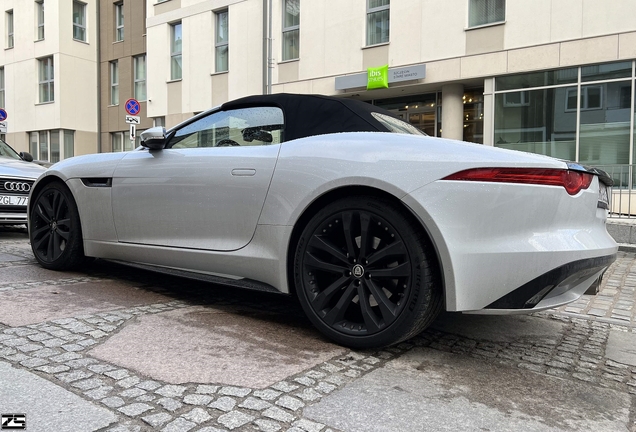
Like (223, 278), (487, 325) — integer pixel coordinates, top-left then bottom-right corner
(0, 227), (636, 432)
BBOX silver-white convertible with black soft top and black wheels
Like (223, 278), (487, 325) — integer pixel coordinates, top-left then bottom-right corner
(29, 94), (617, 348)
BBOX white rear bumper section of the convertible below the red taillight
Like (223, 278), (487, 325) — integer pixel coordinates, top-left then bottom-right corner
(403, 177), (618, 313)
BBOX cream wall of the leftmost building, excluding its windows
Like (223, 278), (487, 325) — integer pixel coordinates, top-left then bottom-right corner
(0, 0), (98, 154)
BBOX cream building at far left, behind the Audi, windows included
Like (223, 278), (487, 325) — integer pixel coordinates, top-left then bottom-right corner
(0, 0), (98, 162)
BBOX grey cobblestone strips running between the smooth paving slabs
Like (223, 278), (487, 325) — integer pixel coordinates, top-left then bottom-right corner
(0, 226), (636, 432)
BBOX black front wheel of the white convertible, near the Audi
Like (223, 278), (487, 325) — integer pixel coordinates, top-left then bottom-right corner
(29, 181), (86, 270)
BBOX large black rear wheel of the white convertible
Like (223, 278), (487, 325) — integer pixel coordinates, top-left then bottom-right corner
(294, 196), (442, 349)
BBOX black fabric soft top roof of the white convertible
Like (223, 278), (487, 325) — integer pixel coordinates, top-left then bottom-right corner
(221, 93), (395, 141)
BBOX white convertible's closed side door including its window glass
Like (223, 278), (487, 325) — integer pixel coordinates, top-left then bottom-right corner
(112, 107), (283, 251)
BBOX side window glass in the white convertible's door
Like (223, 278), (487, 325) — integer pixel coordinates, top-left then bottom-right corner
(167, 107), (284, 149)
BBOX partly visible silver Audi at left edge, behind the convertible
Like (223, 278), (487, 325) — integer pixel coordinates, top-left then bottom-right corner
(0, 140), (46, 225)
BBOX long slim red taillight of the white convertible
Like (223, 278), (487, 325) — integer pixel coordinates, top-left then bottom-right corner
(442, 168), (594, 195)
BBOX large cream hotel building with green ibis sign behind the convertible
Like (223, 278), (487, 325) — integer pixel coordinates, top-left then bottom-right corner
(147, 0), (636, 169)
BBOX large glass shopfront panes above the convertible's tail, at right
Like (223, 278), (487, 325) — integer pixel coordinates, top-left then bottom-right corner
(494, 61), (634, 165)
